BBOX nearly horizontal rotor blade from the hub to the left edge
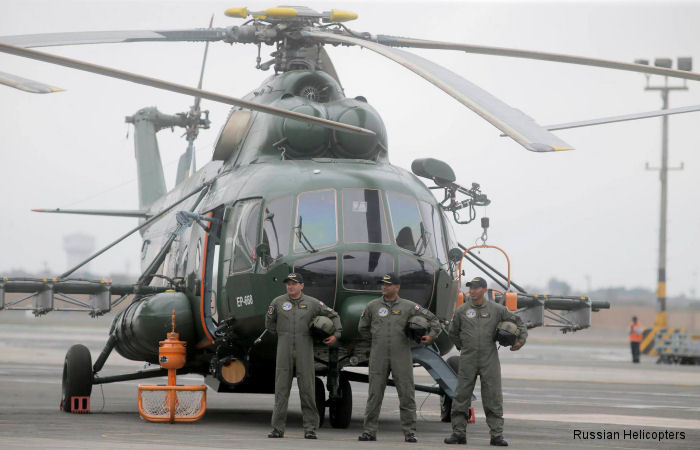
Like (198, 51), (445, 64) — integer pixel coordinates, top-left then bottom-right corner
(0, 28), (230, 48)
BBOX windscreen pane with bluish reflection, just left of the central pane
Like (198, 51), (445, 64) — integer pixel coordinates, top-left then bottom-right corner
(294, 189), (338, 252)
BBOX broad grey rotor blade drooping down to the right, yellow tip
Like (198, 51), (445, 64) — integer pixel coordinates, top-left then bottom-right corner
(302, 30), (573, 152)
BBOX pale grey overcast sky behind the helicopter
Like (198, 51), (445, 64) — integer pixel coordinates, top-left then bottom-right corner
(0, 0), (700, 295)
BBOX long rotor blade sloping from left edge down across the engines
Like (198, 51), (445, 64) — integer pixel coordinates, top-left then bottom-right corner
(0, 43), (375, 136)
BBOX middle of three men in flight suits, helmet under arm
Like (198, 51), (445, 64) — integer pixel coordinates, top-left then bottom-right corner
(357, 272), (441, 442)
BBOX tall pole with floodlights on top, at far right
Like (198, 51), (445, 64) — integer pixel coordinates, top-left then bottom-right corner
(635, 58), (693, 328)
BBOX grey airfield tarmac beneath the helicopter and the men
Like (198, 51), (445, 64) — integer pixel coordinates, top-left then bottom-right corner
(0, 311), (700, 449)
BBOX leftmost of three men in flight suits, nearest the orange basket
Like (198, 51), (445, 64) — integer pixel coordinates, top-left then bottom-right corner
(265, 273), (342, 439)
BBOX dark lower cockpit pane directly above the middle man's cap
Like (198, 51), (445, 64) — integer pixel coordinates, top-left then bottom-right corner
(343, 252), (394, 291)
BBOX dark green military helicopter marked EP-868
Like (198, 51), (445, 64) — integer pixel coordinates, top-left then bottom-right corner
(0, 7), (700, 427)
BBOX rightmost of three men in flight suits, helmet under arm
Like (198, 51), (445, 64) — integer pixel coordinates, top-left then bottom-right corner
(445, 277), (527, 446)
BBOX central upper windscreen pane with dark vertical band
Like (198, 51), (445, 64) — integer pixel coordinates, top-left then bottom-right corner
(343, 189), (389, 244)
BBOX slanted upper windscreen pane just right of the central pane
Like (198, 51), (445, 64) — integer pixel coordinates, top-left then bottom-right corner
(387, 192), (431, 256)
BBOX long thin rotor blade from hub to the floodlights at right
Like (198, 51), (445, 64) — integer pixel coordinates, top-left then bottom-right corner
(373, 35), (700, 81)
